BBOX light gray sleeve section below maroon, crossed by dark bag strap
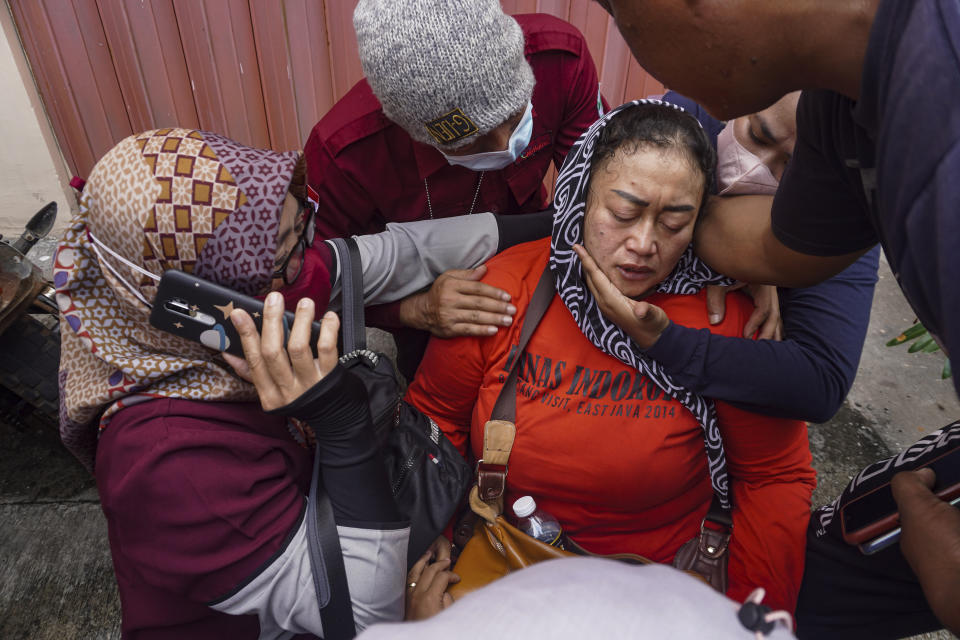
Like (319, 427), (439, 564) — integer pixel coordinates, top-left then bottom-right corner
(211, 520), (410, 640)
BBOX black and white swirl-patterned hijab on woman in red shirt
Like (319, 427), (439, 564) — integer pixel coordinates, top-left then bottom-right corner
(550, 100), (732, 509)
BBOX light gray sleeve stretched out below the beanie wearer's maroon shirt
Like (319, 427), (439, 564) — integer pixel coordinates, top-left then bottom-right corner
(330, 213), (500, 309)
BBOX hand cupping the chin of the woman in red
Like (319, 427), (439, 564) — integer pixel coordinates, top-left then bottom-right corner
(573, 244), (670, 349)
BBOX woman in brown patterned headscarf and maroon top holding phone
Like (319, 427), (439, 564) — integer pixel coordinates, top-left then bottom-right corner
(54, 129), (408, 638)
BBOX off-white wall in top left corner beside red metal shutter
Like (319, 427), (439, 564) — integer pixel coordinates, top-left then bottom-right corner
(0, 2), (77, 236)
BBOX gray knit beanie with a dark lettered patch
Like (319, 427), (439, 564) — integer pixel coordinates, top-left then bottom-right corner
(353, 0), (533, 150)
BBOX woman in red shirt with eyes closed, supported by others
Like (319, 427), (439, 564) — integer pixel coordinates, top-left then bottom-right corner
(408, 101), (814, 611)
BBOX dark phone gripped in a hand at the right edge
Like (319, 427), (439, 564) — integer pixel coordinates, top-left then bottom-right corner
(840, 446), (960, 545)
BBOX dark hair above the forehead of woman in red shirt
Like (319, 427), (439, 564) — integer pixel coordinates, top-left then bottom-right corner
(588, 103), (717, 210)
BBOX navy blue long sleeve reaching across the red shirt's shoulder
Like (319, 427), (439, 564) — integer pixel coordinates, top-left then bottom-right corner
(647, 247), (880, 422)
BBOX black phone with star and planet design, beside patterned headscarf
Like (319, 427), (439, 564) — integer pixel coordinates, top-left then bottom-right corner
(150, 269), (320, 358)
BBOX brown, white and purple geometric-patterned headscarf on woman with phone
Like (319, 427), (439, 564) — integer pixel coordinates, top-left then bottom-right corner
(54, 129), (299, 470)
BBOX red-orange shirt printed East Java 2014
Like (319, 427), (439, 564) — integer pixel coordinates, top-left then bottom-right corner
(407, 239), (815, 611)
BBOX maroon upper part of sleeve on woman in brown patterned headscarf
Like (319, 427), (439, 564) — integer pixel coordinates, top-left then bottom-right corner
(97, 400), (310, 603)
